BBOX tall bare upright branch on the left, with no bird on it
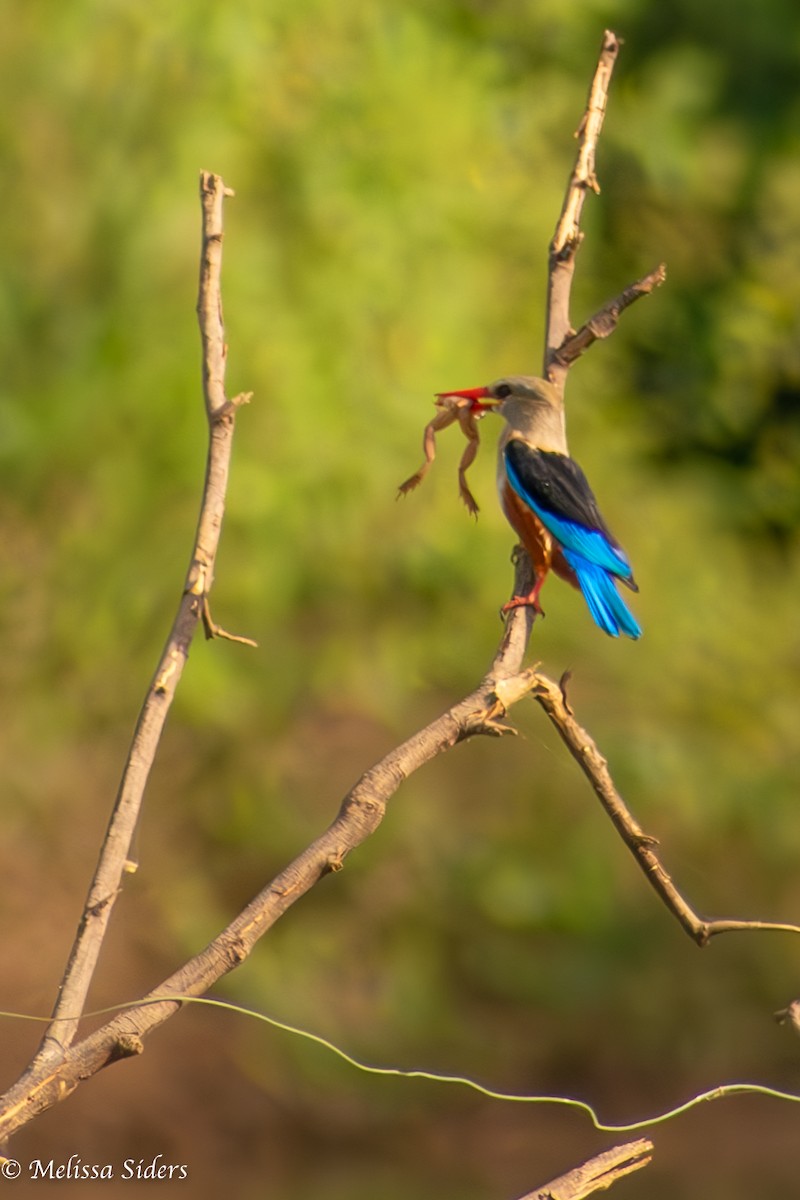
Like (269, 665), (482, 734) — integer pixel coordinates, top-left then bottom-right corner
(31, 173), (245, 1072)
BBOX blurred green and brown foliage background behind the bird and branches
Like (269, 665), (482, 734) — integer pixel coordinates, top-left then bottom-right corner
(0, 0), (800, 1200)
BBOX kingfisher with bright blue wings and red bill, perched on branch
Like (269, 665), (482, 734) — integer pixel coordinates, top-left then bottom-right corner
(438, 376), (642, 638)
